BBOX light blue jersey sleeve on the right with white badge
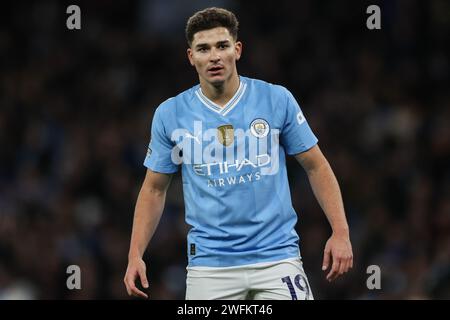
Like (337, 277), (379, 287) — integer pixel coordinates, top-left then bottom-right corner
(280, 88), (318, 155)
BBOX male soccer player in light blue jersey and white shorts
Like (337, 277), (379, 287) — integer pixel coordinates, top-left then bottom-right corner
(124, 8), (353, 300)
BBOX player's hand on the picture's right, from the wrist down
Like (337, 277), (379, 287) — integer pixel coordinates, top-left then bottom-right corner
(322, 234), (353, 282)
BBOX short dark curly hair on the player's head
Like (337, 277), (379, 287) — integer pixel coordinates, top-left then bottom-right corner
(186, 7), (239, 46)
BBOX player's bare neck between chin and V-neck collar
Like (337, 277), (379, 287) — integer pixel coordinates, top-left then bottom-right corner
(200, 73), (240, 107)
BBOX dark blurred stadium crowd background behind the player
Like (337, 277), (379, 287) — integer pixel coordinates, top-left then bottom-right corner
(0, 0), (450, 299)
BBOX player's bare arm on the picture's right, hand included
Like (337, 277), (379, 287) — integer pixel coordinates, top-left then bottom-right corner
(295, 145), (353, 281)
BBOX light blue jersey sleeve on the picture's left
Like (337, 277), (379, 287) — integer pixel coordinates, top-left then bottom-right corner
(144, 104), (178, 173)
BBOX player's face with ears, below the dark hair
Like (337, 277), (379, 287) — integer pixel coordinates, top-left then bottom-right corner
(187, 27), (242, 85)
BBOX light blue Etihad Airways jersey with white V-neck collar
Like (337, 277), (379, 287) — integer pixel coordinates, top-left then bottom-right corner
(144, 77), (317, 267)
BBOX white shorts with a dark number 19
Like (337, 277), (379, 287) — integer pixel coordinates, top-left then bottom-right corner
(186, 258), (314, 300)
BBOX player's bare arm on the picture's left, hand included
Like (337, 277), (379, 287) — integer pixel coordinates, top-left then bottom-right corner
(124, 169), (171, 298)
